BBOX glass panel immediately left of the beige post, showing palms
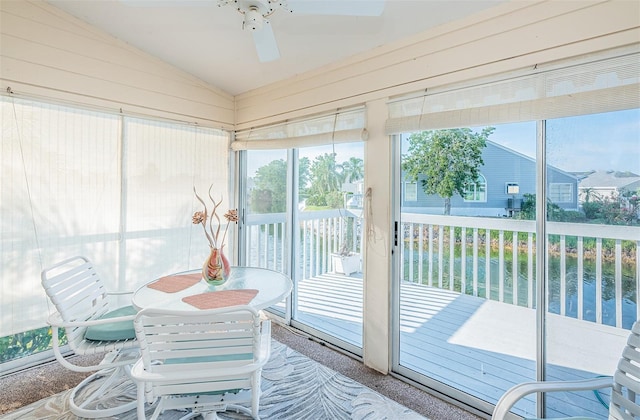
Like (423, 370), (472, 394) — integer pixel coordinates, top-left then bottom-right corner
(291, 143), (364, 353)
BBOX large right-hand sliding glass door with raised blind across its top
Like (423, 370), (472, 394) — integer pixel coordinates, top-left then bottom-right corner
(387, 50), (640, 418)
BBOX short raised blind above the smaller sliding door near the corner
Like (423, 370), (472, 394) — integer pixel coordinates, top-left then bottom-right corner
(231, 107), (368, 150)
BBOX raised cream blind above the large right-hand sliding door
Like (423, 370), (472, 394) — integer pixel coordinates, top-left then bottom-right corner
(386, 53), (640, 135)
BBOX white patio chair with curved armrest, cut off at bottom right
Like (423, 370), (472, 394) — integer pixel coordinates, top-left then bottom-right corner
(491, 321), (640, 420)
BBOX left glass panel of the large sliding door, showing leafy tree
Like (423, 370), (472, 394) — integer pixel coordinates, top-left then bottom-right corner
(396, 123), (536, 415)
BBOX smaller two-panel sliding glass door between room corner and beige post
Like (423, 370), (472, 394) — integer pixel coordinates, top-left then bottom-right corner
(241, 143), (364, 352)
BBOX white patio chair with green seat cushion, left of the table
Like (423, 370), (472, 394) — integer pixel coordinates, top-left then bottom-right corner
(41, 256), (139, 418)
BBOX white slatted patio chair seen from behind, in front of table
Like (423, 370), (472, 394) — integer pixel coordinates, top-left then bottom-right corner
(131, 305), (271, 419)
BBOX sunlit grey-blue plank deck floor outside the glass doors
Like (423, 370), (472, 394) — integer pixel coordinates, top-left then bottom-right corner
(294, 274), (627, 418)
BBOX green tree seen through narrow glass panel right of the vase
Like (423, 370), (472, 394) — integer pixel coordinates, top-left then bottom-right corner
(251, 159), (287, 213)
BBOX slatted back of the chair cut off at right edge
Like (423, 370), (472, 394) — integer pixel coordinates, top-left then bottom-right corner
(609, 321), (640, 420)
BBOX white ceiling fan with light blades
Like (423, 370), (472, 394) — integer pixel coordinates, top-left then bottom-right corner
(218, 0), (384, 63)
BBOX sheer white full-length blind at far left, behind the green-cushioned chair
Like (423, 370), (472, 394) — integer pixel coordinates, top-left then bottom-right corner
(0, 97), (121, 337)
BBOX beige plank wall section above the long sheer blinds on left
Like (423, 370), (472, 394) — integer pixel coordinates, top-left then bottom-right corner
(0, 0), (234, 129)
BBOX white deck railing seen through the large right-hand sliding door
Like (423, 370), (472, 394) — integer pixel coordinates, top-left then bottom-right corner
(401, 213), (640, 328)
